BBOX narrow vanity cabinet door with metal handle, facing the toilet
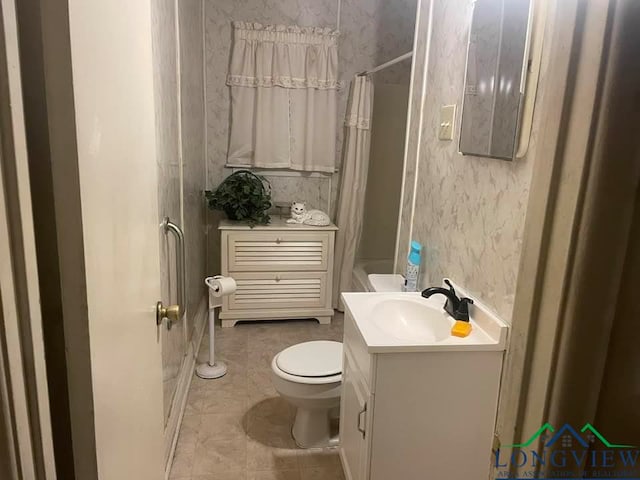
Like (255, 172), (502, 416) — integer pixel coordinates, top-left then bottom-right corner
(340, 350), (370, 480)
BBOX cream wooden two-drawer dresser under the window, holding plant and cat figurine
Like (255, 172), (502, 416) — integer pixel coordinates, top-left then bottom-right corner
(218, 216), (338, 327)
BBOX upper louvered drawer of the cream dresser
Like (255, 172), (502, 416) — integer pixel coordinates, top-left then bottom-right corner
(226, 231), (333, 277)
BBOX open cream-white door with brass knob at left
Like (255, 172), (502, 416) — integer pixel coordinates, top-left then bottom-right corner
(66, 0), (164, 480)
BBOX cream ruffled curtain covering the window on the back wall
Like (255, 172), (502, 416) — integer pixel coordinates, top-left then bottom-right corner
(227, 22), (339, 173)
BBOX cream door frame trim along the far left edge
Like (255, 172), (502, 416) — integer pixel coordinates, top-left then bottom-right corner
(0, 0), (56, 480)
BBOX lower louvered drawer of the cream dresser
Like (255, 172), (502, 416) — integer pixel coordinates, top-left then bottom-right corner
(227, 272), (328, 310)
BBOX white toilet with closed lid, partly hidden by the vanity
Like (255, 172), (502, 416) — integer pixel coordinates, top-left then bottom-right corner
(271, 340), (342, 448)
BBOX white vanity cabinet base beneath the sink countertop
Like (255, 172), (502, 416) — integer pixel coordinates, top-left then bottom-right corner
(339, 288), (506, 480)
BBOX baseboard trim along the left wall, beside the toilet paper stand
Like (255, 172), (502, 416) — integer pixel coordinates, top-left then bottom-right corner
(164, 296), (207, 480)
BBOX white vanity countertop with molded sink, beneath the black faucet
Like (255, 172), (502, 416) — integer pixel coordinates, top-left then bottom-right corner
(342, 285), (508, 353)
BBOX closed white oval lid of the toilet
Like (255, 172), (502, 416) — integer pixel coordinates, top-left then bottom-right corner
(276, 340), (342, 377)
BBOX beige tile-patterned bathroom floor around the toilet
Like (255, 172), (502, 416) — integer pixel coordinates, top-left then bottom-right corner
(170, 314), (344, 480)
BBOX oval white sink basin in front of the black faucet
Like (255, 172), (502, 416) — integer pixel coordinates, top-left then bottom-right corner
(371, 299), (453, 343)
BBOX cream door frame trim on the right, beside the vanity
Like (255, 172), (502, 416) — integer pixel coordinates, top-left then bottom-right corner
(496, 0), (638, 464)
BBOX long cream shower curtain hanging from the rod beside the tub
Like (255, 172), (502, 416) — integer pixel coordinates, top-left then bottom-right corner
(333, 75), (373, 310)
